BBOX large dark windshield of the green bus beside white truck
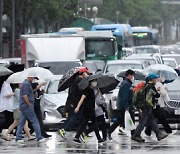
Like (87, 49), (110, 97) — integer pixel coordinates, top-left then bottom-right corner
(85, 38), (115, 59)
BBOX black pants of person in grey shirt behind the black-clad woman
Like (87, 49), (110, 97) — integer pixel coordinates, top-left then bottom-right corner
(85, 115), (107, 140)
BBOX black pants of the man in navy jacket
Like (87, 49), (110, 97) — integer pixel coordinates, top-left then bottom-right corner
(108, 109), (135, 135)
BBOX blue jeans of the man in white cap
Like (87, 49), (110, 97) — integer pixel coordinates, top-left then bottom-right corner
(16, 106), (42, 140)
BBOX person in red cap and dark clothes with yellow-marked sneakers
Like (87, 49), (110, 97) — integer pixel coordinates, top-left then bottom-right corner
(57, 67), (91, 139)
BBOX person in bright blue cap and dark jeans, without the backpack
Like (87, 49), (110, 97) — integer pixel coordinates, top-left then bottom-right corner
(131, 73), (167, 142)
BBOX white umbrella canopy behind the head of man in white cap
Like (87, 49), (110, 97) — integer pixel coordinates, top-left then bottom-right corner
(6, 67), (54, 83)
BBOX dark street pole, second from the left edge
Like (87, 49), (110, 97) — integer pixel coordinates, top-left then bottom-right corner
(9, 0), (16, 57)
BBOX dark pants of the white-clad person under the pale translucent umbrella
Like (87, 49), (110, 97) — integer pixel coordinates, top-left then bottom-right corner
(145, 106), (172, 135)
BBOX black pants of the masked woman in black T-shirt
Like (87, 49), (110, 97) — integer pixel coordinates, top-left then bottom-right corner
(75, 113), (101, 140)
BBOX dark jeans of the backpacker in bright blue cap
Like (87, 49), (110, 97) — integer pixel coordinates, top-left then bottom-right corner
(133, 106), (160, 136)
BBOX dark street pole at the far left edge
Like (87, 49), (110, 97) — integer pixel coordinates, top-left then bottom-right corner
(0, 0), (3, 57)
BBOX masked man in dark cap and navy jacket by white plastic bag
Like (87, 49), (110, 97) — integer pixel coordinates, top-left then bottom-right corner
(107, 69), (135, 140)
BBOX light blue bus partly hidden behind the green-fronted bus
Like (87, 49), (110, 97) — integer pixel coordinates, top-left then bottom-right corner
(91, 24), (133, 59)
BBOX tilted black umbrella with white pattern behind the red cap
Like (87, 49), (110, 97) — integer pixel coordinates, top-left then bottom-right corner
(58, 67), (79, 92)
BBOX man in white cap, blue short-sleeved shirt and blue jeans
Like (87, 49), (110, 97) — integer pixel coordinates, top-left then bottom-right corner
(16, 71), (45, 143)
